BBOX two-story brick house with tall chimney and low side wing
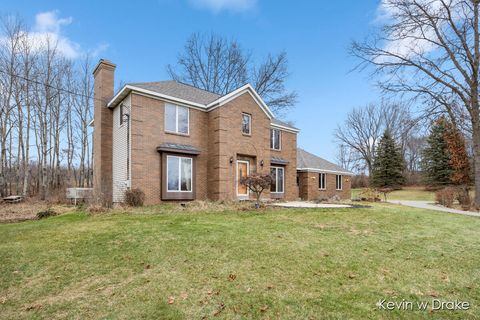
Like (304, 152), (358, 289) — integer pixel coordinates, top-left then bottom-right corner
(93, 60), (350, 204)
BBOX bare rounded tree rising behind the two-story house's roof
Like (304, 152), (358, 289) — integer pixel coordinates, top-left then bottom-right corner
(167, 33), (297, 114)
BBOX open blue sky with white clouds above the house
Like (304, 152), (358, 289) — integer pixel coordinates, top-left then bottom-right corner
(0, 0), (379, 160)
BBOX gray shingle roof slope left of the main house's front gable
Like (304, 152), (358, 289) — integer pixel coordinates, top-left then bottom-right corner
(129, 80), (220, 105)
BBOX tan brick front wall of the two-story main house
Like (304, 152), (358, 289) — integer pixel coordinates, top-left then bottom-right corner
(122, 89), (298, 204)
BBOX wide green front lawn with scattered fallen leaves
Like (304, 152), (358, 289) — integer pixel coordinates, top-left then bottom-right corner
(0, 204), (480, 319)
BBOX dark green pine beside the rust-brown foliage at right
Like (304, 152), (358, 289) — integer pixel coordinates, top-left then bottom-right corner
(422, 117), (453, 187)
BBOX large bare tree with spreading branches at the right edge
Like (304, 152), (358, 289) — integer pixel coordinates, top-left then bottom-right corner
(352, 0), (480, 206)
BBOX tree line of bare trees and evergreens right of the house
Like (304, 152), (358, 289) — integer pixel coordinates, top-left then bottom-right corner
(335, 102), (474, 188)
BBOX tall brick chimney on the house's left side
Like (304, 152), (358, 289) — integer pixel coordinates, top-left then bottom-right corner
(93, 59), (116, 205)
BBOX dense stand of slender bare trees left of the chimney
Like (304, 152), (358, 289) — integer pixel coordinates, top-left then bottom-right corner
(0, 16), (93, 199)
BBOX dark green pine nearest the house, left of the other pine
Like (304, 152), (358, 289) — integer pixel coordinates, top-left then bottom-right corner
(372, 130), (405, 188)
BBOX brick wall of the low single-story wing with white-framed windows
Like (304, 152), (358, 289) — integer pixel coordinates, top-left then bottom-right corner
(298, 172), (352, 200)
